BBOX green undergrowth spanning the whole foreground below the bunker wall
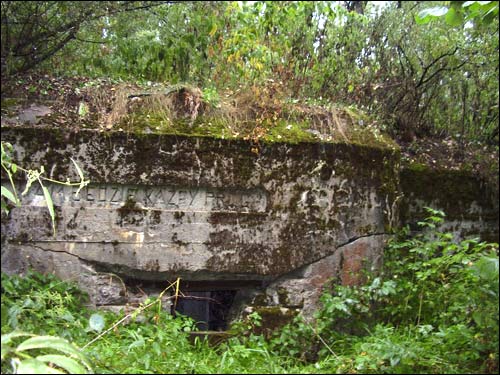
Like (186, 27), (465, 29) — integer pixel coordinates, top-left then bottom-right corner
(2, 209), (499, 373)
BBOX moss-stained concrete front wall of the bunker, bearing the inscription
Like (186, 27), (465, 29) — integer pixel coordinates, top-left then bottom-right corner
(2, 128), (399, 318)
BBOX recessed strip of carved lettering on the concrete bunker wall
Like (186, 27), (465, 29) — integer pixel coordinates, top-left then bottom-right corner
(23, 184), (267, 212)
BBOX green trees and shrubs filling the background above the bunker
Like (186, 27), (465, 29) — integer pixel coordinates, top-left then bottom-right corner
(1, 1), (499, 144)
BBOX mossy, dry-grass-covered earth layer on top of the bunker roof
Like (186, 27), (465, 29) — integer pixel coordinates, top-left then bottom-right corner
(2, 78), (396, 148)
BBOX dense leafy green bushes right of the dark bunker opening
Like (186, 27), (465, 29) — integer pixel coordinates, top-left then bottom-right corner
(272, 208), (499, 373)
